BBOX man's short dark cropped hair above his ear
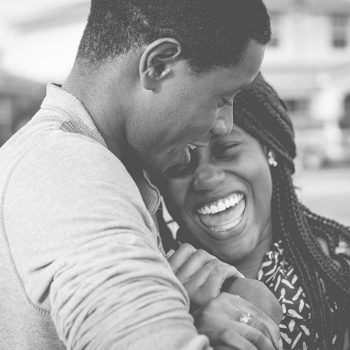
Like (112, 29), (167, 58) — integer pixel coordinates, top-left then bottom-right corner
(78, 0), (271, 72)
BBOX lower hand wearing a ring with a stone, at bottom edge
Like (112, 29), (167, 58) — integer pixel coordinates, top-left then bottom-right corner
(194, 293), (283, 350)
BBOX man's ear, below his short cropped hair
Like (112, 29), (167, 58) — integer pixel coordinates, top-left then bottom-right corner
(139, 38), (181, 90)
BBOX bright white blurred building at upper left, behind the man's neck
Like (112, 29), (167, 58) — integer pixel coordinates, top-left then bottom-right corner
(0, 0), (90, 83)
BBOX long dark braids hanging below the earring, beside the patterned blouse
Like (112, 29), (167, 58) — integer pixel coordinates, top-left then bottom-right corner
(272, 167), (333, 349)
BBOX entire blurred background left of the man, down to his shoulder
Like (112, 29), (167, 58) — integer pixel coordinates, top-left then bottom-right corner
(0, 0), (90, 146)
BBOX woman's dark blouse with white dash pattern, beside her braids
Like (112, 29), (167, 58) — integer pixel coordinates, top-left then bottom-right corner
(258, 241), (344, 350)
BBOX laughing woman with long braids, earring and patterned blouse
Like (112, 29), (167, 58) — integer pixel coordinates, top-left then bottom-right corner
(158, 75), (350, 350)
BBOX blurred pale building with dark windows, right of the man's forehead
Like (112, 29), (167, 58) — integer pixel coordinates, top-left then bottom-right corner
(263, 0), (350, 165)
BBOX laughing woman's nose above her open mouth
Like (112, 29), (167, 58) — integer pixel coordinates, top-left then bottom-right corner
(193, 163), (225, 191)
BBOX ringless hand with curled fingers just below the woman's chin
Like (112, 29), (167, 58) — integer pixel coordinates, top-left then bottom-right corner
(167, 243), (243, 310)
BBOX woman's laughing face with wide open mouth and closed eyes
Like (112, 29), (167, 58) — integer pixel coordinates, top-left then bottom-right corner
(163, 125), (272, 262)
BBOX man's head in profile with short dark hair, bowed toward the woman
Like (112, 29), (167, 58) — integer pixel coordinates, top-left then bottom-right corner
(77, 0), (270, 172)
